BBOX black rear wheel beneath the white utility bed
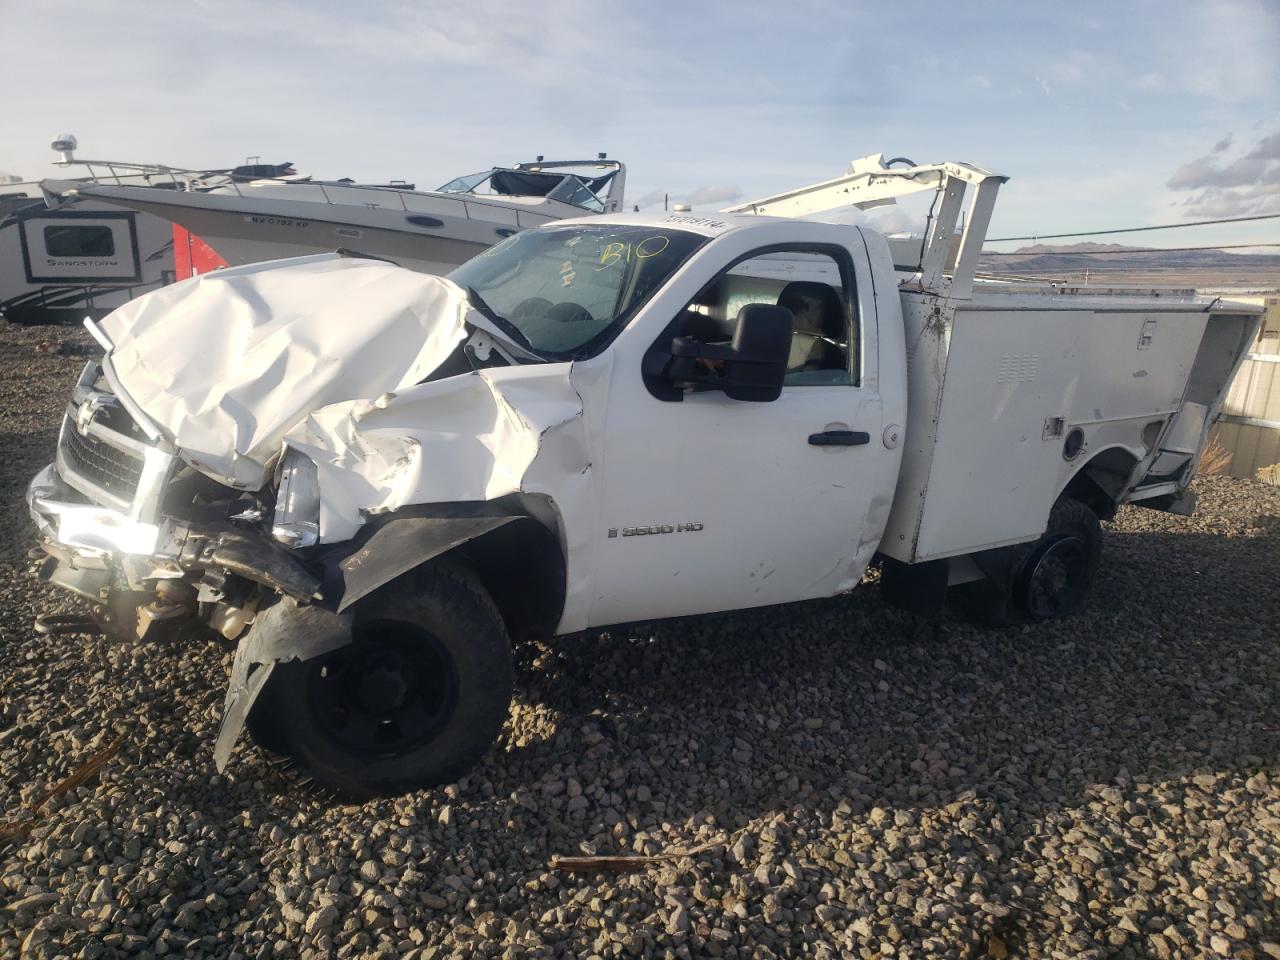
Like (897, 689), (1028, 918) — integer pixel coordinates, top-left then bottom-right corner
(955, 497), (1102, 626)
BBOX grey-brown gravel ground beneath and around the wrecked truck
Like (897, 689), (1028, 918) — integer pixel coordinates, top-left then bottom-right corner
(0, 328), (1280, 960)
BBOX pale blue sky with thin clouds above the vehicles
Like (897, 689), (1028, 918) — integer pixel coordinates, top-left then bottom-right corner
(0, 0), (1280, 252)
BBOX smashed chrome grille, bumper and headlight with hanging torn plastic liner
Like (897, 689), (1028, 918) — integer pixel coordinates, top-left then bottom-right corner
(27, 361), (351, 769)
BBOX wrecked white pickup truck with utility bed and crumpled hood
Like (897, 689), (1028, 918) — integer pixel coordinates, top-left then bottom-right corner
(28, 157), (1258, 795)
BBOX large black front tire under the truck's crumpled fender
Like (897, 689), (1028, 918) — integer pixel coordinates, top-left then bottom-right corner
(250, 563), (515, 799)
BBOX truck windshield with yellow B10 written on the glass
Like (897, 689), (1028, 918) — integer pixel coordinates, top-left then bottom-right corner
(449, 224), (707, 360)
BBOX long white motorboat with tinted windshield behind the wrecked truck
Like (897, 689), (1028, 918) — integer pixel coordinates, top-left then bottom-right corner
(45, 154), (626, 274)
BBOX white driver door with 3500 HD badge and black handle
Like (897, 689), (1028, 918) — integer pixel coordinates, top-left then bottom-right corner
(590, 246), (896, 625)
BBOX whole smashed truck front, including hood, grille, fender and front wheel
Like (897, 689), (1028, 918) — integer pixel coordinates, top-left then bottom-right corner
(27, 249), (591, 795)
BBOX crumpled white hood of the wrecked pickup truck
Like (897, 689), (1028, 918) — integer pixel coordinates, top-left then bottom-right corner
(101, 253), (471, 490)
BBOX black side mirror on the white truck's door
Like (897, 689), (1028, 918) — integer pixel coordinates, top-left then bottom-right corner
(666, 303), (795, 402)
